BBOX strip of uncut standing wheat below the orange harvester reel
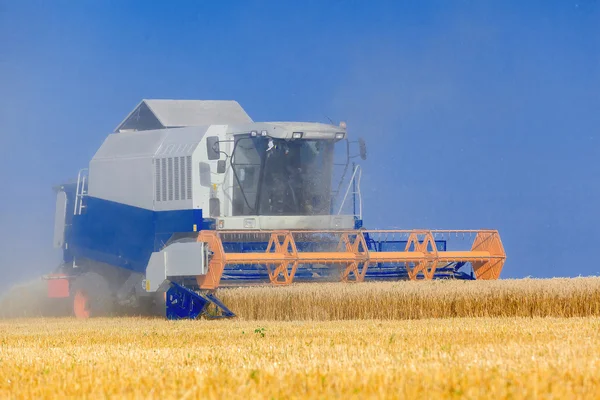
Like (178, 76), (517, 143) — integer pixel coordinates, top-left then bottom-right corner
(217, 278), (600, 321)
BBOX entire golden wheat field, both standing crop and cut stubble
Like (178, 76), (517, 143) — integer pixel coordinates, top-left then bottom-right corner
(0, 278), (600, 399)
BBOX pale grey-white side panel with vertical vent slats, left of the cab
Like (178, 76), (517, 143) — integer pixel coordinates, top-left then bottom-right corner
(88, 126), (213, 211)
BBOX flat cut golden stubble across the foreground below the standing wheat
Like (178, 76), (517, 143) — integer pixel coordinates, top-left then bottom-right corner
(0, 317), (600, 399)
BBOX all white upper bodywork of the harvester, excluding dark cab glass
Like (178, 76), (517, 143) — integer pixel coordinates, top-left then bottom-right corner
(88, 101), (346, 229)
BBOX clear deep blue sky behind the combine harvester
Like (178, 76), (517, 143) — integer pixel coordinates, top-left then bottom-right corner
(0, 0), (600, 280)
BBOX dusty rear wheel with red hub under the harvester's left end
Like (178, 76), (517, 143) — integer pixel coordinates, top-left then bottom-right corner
(71, 272), (115, 318)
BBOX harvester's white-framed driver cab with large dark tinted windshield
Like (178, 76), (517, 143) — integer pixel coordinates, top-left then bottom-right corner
(201, 122), (355, 230)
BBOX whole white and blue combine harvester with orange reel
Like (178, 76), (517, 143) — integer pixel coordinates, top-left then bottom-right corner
(45, 100), (505, 319)
